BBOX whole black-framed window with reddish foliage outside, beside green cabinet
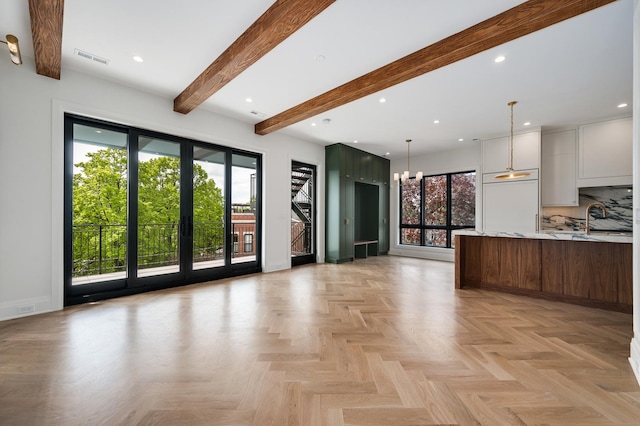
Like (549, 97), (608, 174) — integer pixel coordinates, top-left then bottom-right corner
(400, 172), (476, 248)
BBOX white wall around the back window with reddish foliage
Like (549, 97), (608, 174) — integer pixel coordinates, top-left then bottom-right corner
(389, 142), (482, 262)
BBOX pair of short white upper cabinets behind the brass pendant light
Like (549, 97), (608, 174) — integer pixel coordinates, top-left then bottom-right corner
(482, 131), (540, 173)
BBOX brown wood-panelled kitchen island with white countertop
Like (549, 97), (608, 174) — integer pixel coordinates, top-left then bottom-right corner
(455, 231), (633, 313)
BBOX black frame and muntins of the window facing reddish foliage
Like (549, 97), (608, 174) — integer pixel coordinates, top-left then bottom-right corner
(398, 170), (478, 249)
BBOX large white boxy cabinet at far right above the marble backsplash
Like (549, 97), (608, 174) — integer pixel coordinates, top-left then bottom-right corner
(578, 117), (633, 187)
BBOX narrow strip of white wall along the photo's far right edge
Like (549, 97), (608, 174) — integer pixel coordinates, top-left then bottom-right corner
(629, 0), (640, 383)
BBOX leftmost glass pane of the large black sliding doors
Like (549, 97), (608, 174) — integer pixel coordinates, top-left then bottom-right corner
(71, 124), (128, 285)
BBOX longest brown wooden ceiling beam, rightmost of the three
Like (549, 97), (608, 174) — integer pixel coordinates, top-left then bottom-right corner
(255, 0), (615, 135)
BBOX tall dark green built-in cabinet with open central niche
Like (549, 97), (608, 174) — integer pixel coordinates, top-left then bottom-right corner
(325, 144), (390, 263)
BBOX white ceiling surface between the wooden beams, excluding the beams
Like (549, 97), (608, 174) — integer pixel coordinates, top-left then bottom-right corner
(0, 0), (633, 158)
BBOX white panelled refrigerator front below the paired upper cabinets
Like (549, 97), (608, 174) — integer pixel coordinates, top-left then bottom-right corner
(482, 169), (540, 232)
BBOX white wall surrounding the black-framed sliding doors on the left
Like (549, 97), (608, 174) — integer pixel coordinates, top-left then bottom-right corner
(0, 58), (324, 320)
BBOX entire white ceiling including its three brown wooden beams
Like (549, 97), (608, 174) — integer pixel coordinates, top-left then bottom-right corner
(0, 0), (633, 158)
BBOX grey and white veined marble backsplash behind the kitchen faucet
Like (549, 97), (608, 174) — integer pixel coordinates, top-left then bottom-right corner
(541, 186), (633, 232)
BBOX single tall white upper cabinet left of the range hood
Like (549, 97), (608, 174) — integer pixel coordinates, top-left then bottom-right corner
(540, 129), (579, 206)
